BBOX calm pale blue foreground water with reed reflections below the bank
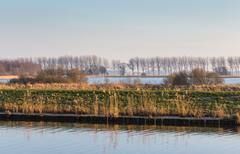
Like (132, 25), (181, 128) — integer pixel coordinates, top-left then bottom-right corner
(0, 122), (240, 154)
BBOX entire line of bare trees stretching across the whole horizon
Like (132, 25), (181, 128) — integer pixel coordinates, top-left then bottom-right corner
(0, 55), (240, 76)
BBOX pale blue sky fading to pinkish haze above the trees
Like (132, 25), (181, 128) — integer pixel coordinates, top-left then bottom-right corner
(0, 0), (240, 60)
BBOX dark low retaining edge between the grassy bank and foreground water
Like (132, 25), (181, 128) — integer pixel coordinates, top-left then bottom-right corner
(0, 112), (236, 127)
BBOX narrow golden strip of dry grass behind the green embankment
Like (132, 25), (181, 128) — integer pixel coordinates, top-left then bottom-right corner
(0, 83), (240, 92)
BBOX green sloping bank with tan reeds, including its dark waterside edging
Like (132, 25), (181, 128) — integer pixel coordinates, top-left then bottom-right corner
(0, 89), (240, 125)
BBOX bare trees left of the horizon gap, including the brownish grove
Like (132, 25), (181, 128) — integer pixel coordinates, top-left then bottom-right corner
(0, 56), (109, 75)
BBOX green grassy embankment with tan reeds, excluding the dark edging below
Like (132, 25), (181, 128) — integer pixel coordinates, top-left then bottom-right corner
(0, 88), (240, 121)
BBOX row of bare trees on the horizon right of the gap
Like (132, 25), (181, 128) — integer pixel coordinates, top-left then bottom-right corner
(112, 57), (240, 75)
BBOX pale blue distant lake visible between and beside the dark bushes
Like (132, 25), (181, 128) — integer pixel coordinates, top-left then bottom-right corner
(88, 77), (240, 84)
